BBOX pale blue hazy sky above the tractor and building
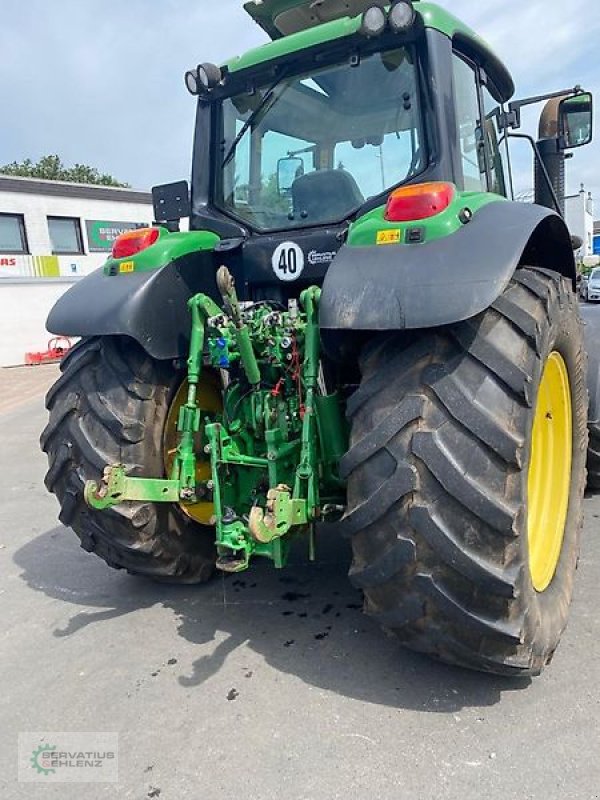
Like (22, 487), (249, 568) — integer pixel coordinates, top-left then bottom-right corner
(0, 0), (600, 203)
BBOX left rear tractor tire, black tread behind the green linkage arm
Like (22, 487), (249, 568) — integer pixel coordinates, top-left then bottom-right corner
(41, 337), (215, 583)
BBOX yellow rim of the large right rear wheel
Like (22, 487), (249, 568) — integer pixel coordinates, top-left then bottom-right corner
(527, 351), (573, 592)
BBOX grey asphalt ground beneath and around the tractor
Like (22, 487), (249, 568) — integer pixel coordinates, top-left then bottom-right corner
(0, 367), (600, 800)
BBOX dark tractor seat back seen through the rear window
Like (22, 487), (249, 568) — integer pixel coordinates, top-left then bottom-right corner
(292, 169), (365, 223)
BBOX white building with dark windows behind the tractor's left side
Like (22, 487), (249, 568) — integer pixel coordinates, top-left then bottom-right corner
(0, 175), (153, 366)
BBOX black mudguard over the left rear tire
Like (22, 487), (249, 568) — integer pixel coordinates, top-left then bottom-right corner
(46, 252), (219, 359)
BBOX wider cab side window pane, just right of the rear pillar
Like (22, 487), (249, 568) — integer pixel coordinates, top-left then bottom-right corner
(453, 54), (488, 192)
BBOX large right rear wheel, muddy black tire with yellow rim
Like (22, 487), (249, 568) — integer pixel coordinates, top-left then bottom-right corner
(342, 269), (587, 675)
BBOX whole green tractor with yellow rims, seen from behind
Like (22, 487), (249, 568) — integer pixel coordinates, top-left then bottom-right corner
(42, 0), (592, 676)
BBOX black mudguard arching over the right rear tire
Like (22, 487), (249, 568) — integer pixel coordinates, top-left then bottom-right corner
(320, 202), (576, 334)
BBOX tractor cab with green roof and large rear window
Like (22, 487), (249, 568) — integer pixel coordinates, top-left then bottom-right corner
(157, 0), (513, 301)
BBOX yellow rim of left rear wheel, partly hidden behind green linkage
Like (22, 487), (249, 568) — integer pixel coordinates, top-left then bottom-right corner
(163, 371), (223, 525)
